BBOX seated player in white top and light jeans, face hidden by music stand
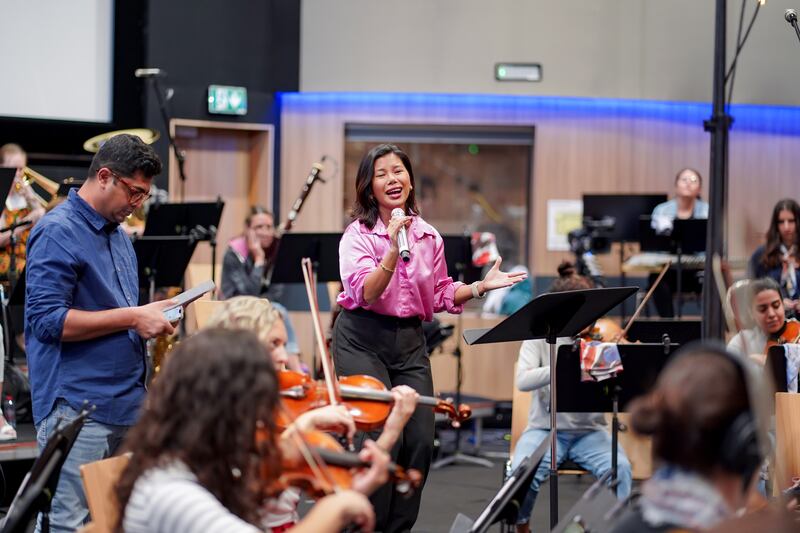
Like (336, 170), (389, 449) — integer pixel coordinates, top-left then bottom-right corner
(512, 263), (631, 532)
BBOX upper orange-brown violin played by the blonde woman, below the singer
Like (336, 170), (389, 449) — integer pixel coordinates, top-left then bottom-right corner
(278, 370), (472, 431)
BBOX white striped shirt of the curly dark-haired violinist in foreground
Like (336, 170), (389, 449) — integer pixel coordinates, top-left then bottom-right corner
(123, 462), (260, 533)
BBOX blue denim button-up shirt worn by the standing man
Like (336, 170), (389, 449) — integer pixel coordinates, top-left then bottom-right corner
(25, 189), (145, 426)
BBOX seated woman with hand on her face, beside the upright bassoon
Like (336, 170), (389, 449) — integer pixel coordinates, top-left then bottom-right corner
(220, 205), (300, 370)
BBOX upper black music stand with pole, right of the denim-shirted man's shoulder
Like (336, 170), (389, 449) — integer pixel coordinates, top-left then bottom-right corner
(143, 200), (225, 282)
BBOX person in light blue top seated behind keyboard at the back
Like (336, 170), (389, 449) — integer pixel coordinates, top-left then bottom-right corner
(648, 168), (708, 318)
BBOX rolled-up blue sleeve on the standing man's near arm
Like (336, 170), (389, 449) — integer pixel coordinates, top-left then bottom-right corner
(25, 232), (78, 343)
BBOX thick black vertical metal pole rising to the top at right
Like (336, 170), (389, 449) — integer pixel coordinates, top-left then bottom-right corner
(703, 0), (732, 339)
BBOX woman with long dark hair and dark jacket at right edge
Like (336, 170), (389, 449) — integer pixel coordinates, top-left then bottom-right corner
(748, 198), (800, 318)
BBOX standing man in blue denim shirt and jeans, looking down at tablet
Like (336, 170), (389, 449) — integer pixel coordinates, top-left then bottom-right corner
(25, 134), (174, 531)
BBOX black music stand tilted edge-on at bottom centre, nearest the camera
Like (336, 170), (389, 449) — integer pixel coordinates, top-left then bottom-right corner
(450, 431), (553, 533)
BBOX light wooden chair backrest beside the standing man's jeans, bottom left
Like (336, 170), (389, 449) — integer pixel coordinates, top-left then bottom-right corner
(81, 454), (130, 533)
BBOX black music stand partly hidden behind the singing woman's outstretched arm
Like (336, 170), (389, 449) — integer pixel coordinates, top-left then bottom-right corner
(431, 235), (484, 469)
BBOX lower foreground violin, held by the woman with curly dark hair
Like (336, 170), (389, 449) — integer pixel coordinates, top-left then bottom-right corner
(268, 431), (422, 498)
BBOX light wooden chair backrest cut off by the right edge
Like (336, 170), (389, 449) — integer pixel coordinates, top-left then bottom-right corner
(772, 392), (800, 496)
